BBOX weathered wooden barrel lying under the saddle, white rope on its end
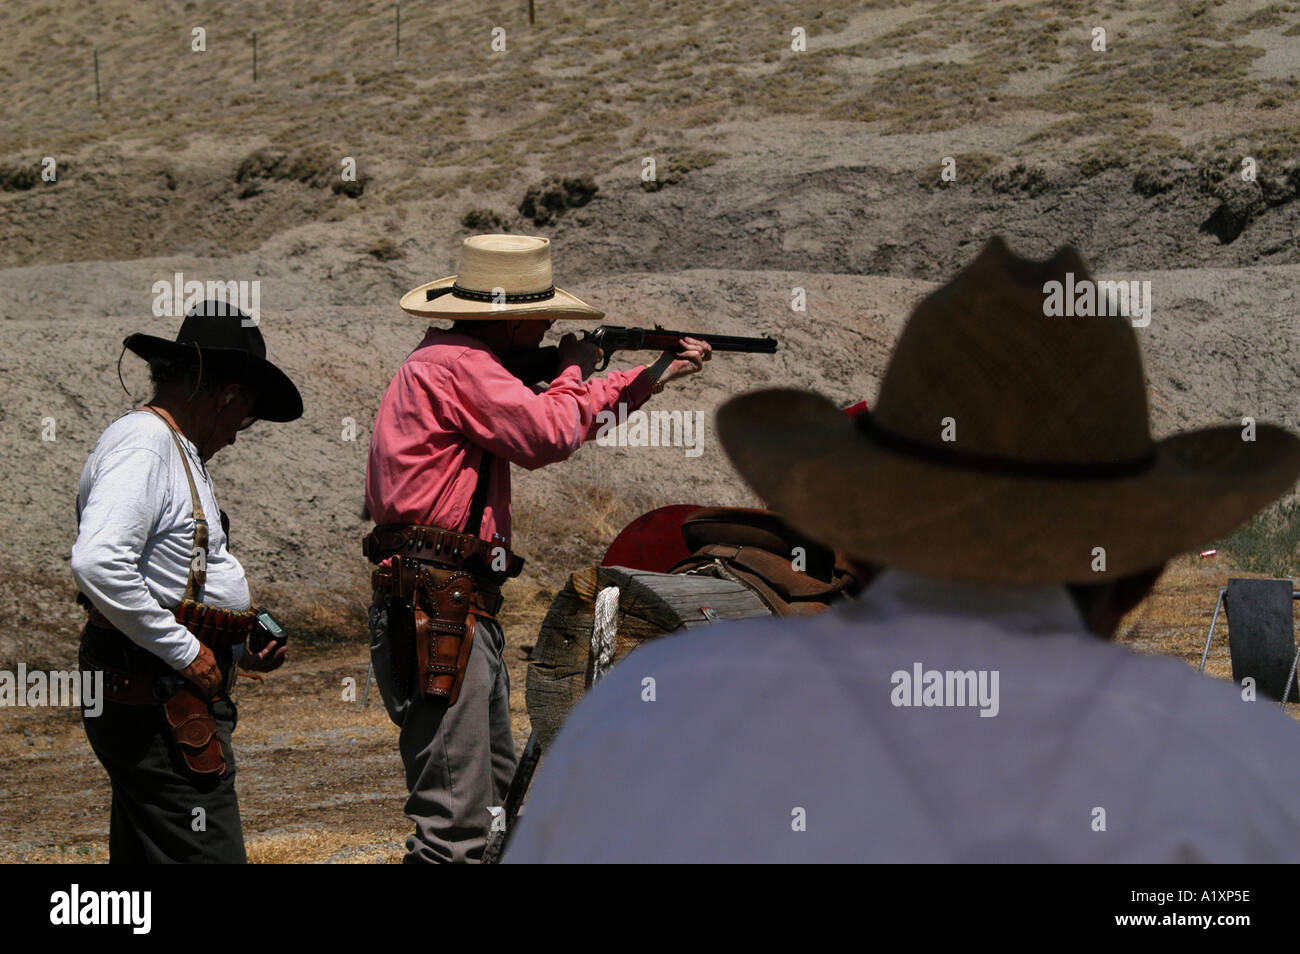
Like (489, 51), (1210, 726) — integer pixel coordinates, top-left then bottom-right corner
(527, 567), (771, 751)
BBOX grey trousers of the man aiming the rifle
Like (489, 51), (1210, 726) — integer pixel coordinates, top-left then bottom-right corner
(371, 603), (515, 864)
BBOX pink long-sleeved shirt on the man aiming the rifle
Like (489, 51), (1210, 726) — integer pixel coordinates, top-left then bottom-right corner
(365, 329), (654, 548)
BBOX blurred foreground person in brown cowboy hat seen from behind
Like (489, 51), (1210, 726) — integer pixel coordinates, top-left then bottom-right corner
(506, 239), (1300, 862)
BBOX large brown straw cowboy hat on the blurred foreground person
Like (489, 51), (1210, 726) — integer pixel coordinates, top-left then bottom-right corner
(718, 238), (1300, 584)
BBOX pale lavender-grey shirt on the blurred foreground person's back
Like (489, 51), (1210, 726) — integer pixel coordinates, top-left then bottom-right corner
(506, 572), (1300, 863)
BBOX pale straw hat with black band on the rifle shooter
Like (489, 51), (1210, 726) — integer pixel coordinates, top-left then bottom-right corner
(402, 235), (605, 321)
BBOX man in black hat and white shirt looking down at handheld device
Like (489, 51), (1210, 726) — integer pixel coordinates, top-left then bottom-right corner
(72, 302), (302, 862)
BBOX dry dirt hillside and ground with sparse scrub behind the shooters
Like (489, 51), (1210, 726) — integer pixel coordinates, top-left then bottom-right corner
(0, 0), (1300, 860)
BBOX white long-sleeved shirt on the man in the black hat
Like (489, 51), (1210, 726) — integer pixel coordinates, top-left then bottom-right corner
(72, 411), (248, 669)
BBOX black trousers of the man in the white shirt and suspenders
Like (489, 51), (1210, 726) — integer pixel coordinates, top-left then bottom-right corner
(82, 637), (248, 864)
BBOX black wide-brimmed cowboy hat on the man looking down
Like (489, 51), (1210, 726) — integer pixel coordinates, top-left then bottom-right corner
(122, 302), (303, 422)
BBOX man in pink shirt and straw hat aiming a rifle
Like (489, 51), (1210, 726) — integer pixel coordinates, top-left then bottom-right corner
(365, 235), (710, 863)
